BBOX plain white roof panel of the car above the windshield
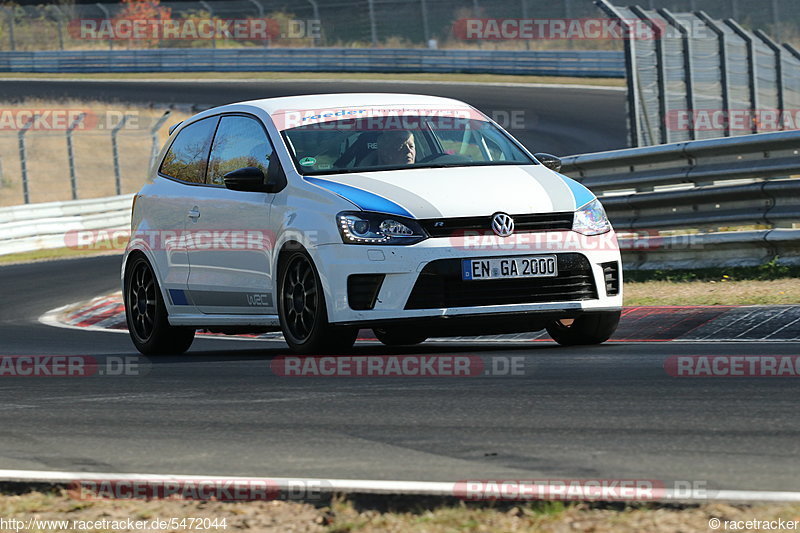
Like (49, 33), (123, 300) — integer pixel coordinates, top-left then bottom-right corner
(223, 93), (470, 115)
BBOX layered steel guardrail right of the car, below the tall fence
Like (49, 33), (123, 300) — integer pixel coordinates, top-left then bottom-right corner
(562, 131), (800, 268)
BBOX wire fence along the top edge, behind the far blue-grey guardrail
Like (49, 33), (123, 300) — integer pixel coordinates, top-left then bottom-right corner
(0, 0), (800, 50)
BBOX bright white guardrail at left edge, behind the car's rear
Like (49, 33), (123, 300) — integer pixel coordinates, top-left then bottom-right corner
(0, 194), (133, 255)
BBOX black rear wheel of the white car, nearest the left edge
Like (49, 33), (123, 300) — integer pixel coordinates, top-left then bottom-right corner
(124, 254), (195, 355)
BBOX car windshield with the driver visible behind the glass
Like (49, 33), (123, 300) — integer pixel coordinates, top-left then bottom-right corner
(283, 115), (536, 175)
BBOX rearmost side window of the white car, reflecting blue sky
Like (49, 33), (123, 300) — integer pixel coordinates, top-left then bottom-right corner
(159, 117), (217, 183)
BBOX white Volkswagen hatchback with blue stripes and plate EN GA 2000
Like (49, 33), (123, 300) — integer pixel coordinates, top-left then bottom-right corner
(122, 94), (622, 354)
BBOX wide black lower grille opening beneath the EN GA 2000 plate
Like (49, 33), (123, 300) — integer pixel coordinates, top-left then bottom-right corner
(406, 253), (597, 309)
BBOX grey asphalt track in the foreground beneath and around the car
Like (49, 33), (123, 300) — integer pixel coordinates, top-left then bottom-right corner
(0, 256), (800, 490)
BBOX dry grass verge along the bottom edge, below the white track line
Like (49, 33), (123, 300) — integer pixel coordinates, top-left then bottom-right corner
(0, 491), (800, 533)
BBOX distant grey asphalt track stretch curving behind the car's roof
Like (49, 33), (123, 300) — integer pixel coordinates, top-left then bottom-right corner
(0, 75), (627, 156)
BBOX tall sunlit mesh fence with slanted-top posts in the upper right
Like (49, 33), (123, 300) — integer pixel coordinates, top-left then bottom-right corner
(598, 0), (800, 146)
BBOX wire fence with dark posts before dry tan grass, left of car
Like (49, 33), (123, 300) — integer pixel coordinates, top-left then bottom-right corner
(0, 103), (191, 206)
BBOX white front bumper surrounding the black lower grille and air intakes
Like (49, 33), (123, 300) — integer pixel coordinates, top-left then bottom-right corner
(311, 231), (622, 327)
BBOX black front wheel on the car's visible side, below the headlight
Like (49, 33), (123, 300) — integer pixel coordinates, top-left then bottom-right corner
(278, 251), (358, 354)
